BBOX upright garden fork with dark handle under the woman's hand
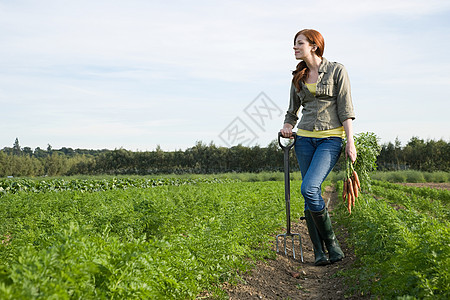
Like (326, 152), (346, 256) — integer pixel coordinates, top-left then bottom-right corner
(276, 132), (303, 262)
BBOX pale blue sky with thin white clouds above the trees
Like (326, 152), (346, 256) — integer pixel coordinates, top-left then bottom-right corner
(0, 0), (450, 151)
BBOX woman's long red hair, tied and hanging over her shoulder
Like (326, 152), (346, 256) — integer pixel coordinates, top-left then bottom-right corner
(292, 29), (325, 91)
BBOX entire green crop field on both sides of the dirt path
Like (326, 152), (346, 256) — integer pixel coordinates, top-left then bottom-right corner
(0, 176), (450, 299)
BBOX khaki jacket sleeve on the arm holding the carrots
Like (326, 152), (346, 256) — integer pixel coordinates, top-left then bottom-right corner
(335, 65), (355, 123)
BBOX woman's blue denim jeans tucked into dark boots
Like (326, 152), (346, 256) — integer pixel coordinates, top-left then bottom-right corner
(294, 136), (342, 211)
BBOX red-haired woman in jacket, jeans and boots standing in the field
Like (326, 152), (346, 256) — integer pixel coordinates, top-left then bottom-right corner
(280, 29), (356, 265)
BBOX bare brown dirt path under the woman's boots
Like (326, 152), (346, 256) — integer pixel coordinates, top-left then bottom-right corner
(225, 187), (369, 300)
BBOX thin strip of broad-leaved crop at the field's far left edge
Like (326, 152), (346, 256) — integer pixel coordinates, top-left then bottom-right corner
(0, 177), (237, 196)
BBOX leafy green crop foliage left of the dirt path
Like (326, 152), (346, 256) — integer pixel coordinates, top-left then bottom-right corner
(0, 180), (303, 299)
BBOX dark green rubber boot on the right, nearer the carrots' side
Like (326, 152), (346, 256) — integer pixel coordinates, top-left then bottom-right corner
(311, 208), (345, 263)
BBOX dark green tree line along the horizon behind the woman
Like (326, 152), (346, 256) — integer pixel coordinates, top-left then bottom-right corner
(0, 137), (450, 177)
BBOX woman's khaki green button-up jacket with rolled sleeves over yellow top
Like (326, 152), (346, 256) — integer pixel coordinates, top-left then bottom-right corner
(284, 58), (355, 131)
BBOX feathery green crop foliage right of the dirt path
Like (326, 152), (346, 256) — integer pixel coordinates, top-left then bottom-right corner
(338, 182), (450, 299)
